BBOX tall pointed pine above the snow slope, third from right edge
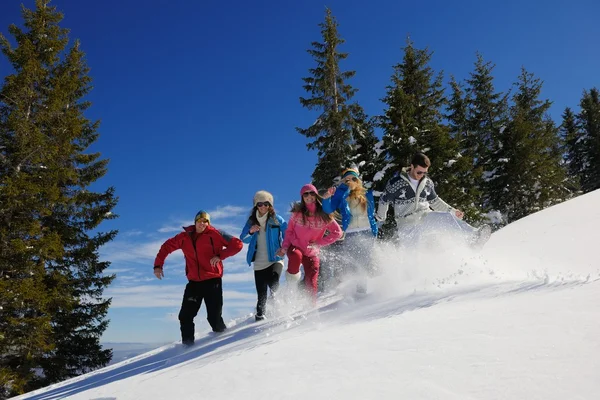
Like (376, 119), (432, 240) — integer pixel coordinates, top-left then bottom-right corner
(489, 69), (568, 222)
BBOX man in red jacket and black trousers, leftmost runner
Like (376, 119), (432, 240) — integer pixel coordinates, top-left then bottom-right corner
(154, 211), (242, 346)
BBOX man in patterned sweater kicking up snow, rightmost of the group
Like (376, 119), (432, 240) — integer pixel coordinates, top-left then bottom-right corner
(376, 153), (491, 247)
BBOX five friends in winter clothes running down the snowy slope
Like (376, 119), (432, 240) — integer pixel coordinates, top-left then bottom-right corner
(154, 153), (491, 346)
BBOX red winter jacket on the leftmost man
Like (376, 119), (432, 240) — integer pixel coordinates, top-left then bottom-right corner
(154, 225), (243, 281)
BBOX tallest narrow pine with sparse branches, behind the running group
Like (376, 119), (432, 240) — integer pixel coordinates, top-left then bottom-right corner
(296, 9), (364, 188)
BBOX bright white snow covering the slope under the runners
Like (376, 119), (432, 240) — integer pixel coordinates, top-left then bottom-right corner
(12, 191), (600, 400)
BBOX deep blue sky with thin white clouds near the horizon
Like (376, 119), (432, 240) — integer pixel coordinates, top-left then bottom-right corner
(0, 0), (600, 342)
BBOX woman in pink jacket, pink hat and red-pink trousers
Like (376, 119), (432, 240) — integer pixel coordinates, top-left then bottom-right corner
(277, 184), (342, 299)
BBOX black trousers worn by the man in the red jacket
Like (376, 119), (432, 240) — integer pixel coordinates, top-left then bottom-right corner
(179, 278), (226, 342)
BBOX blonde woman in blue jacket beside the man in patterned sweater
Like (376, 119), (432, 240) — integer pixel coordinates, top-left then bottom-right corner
(323, 168), (378, 294)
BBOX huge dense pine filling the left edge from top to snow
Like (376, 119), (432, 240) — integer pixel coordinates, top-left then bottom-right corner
(0, 0), (116, 396)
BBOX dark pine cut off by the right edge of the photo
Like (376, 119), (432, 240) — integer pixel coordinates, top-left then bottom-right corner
(577, 88), (600, 193)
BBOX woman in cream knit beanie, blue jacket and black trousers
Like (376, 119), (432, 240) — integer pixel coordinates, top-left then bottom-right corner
(240, 190), (287, 321)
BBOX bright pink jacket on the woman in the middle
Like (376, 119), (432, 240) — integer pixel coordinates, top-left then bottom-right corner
(281, 212), (342, 256)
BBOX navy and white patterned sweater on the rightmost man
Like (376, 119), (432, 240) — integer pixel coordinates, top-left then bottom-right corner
(376, 172), (455, 225)
